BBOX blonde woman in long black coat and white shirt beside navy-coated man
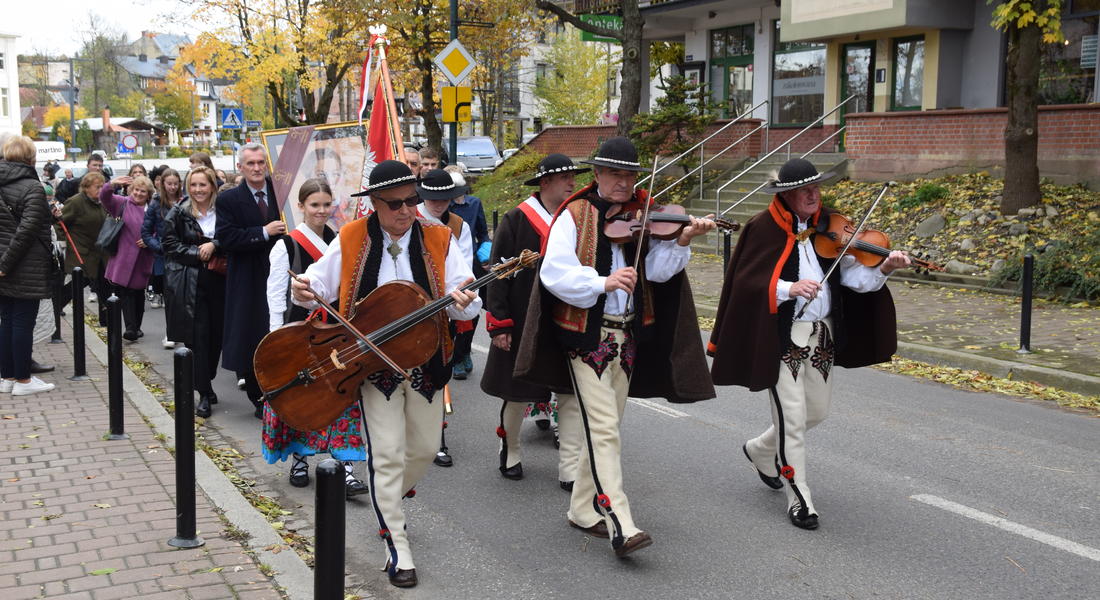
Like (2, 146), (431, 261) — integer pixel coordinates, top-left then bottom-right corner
(161, 167), (229, 418)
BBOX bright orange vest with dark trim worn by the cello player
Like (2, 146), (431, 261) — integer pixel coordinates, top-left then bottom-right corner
(339, 215), (453, 364)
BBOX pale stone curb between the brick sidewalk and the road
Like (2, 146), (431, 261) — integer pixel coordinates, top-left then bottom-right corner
(72, 317), (314, 600)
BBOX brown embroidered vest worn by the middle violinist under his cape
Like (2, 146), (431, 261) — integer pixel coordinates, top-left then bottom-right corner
(552, 186), (656, 350)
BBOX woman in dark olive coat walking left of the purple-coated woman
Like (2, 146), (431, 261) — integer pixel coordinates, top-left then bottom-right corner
(62, 171), (109, 327)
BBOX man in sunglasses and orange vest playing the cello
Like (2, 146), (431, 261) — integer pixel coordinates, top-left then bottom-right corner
(292, 161), (481, 588)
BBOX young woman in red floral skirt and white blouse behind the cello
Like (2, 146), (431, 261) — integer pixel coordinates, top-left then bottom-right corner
(261, 178), (369, 498)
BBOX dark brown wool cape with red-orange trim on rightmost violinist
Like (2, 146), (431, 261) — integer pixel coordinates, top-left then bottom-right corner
(707, 196), (898, 392)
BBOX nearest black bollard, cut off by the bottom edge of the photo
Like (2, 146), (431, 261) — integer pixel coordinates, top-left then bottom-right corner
(314, 458), (344, 600)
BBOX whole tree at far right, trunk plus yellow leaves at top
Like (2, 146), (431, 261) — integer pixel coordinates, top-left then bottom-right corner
(988, 0), (1063, 215)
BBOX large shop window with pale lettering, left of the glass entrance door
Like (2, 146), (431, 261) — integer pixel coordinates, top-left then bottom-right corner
(771, 21), (825, 126)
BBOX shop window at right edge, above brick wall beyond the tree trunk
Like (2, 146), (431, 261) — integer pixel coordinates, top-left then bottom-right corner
(1038, 13), (1100, 105)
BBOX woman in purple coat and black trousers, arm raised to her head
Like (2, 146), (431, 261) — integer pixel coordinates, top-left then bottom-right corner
(99, 175), (154, 341)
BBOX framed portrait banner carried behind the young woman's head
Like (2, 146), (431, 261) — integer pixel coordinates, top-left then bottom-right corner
(260, 121), (369, 231)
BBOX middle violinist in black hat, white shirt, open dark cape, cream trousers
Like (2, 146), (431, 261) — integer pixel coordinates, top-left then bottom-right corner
(515, 138), (715, 557)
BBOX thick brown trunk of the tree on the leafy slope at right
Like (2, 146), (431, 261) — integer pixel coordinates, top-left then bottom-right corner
(1001, 12), (1046, 216)
